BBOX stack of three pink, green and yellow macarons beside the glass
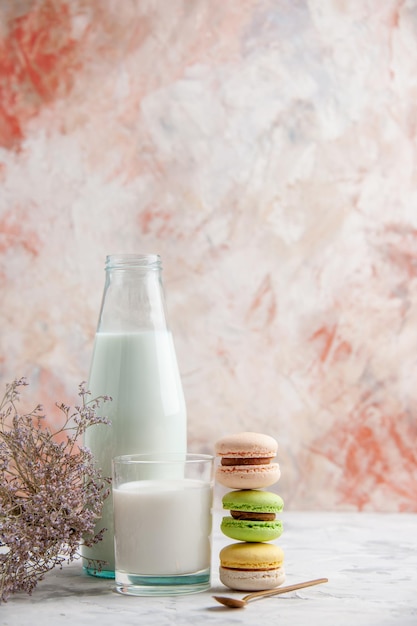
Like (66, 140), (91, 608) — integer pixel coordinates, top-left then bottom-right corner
(215, 432), (285, 591)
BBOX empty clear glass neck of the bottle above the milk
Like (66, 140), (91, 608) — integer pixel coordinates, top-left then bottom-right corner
(97, 254), (167, 333)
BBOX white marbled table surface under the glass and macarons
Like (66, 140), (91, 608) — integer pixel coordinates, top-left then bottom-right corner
(0, 511), (417, 626)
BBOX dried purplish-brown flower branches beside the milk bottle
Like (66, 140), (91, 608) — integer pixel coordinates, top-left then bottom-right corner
(0, 378), (111, 603)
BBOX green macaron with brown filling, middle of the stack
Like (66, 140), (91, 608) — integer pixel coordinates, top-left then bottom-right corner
(221, 489), (284, 542)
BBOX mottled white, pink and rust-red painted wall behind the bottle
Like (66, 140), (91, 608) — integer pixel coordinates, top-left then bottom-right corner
(0, 0), (417, 511)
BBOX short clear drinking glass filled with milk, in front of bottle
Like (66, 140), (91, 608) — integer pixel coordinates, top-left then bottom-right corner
(113, 453), (214, 596)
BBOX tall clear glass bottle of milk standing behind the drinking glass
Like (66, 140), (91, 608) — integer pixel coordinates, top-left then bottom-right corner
(82, 254), (187, 578)
